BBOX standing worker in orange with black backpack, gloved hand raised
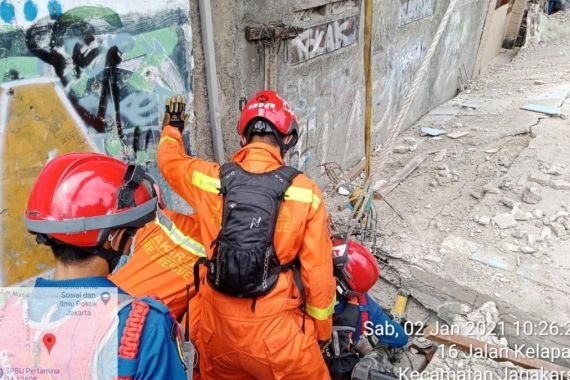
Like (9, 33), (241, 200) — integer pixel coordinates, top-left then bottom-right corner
(157, 91), (335, 380)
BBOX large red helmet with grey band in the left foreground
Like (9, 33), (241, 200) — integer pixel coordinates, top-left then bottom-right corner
(25, 153), (162, 247)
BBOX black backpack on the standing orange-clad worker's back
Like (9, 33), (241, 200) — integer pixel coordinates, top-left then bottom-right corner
(194, 163), (305, 310)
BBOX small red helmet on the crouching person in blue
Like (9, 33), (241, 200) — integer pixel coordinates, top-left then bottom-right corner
(333, 239), (380, 294)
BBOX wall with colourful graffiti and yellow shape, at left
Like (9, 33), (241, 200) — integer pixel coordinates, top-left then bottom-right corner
(0, 0), (193, 286)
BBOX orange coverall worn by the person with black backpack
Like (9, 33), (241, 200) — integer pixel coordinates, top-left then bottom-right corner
(157, 126), (335, 380)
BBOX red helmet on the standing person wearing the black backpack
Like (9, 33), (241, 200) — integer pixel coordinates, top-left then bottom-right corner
(238, 91), (299, 152)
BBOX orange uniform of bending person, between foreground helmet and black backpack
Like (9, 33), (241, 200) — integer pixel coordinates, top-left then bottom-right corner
(109, 210), (206, 318)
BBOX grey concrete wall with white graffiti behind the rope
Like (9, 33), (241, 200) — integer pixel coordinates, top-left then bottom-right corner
(214, 0), (488, 183)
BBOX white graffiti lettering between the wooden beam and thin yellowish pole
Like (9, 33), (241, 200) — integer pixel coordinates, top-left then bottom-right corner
(289, 16), (359, 64)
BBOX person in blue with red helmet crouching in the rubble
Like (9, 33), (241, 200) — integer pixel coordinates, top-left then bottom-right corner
(323, 239), (408, 380)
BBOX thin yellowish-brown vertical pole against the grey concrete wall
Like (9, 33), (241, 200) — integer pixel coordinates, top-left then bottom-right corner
(364, 0), (374, 178)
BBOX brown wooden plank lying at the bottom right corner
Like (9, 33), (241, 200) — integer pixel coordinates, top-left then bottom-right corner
(424, 326), (570, 379)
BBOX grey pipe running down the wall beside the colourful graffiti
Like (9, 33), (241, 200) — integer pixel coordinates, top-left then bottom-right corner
(198, 0), (225, 164)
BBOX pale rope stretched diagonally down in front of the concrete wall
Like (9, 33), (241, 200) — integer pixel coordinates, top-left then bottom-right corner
(347, 0), (458, 236)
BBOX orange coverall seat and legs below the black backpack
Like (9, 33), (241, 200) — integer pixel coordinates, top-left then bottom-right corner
(198, 302), (330, 380)
